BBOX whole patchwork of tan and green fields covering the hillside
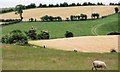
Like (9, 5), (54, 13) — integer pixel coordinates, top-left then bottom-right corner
(0, 6), (120, 70)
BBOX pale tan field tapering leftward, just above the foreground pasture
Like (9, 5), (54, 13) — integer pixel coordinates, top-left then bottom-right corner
(29, 35), (118, 53)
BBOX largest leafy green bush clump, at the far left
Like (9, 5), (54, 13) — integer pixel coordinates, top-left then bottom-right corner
(1, 30), (28, 45)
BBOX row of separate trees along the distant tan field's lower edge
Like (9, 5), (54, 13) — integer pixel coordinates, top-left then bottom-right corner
(10, 5), (119, 21)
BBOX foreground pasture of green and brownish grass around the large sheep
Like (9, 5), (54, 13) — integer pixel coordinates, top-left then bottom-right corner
(2, 44), (118, 70)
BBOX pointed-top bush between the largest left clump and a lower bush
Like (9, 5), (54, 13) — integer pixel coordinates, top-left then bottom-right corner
(25, 26), (37, 40)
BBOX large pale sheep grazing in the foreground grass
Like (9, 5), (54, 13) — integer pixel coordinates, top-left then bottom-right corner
(92, 60), (107, 70)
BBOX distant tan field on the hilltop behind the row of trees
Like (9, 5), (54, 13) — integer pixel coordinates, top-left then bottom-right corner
(1, 6), (117, 21)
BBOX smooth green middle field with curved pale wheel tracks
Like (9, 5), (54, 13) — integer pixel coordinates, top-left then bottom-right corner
(2, 14), (118, 38)
